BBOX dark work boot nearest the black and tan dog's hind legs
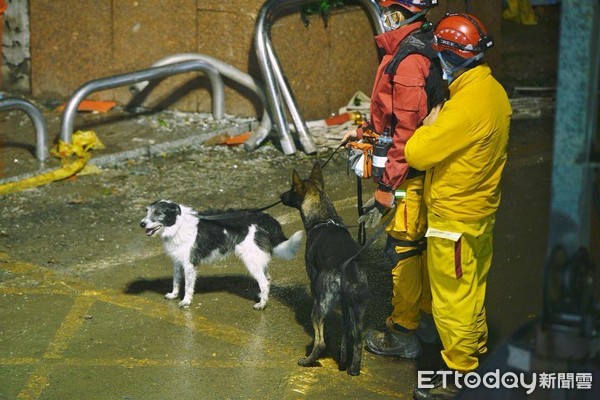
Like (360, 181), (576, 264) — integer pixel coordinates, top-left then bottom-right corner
(365, 323), (421, 359)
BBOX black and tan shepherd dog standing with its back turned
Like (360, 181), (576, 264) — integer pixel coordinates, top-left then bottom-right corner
(281, 162), (369, 375)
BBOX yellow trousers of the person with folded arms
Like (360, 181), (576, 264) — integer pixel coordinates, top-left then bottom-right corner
(427, 213), (494, 372)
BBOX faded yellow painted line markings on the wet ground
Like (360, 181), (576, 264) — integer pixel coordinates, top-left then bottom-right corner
(0, 252), (404, 400)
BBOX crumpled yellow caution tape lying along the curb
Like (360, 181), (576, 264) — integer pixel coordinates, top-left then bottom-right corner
(0, 131), (104, 195)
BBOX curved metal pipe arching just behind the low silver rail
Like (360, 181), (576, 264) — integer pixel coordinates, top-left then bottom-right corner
(132, 53), (272, 150)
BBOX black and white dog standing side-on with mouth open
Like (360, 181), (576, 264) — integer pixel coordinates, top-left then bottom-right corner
(140, 200), (302, 310)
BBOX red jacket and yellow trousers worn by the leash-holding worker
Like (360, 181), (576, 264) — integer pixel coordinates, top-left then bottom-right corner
(370, 21), (447, 330)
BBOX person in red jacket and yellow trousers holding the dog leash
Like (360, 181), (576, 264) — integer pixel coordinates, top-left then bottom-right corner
(343, 0), (447, 359)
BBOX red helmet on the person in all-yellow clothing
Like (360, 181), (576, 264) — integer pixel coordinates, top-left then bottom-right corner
(433, 13), (494, 58)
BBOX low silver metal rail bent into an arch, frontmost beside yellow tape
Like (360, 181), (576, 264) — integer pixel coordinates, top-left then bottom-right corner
(60, 60), (225, 143)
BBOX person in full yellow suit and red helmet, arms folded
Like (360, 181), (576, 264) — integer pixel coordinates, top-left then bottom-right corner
(405, 14), (512, 400)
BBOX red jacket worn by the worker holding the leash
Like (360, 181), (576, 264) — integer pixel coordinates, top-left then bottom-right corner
(358, 22), (441, 189)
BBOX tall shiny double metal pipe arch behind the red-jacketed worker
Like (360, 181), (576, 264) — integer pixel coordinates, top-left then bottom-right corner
(254, 0), (384, 154)
